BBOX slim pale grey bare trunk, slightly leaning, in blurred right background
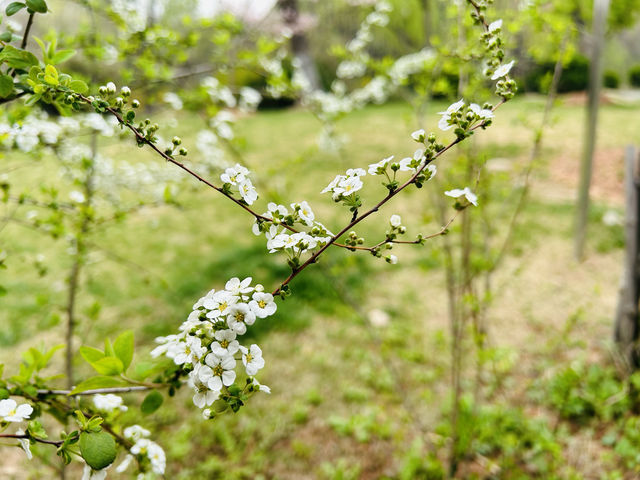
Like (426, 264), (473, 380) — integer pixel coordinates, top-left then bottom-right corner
(574, 0), (609, 261)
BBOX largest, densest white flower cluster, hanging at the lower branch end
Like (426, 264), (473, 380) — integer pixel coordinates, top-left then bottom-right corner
(151, 277), (277, 414)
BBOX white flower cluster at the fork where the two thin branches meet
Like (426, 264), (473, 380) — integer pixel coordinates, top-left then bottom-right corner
(253, 201), (333, 258)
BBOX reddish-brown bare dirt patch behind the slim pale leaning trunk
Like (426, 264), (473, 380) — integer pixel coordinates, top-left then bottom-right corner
(549, 147), (624, 205)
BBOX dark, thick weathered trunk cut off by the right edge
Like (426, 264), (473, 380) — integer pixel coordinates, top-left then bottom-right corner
(614, 146), (640, 370)
